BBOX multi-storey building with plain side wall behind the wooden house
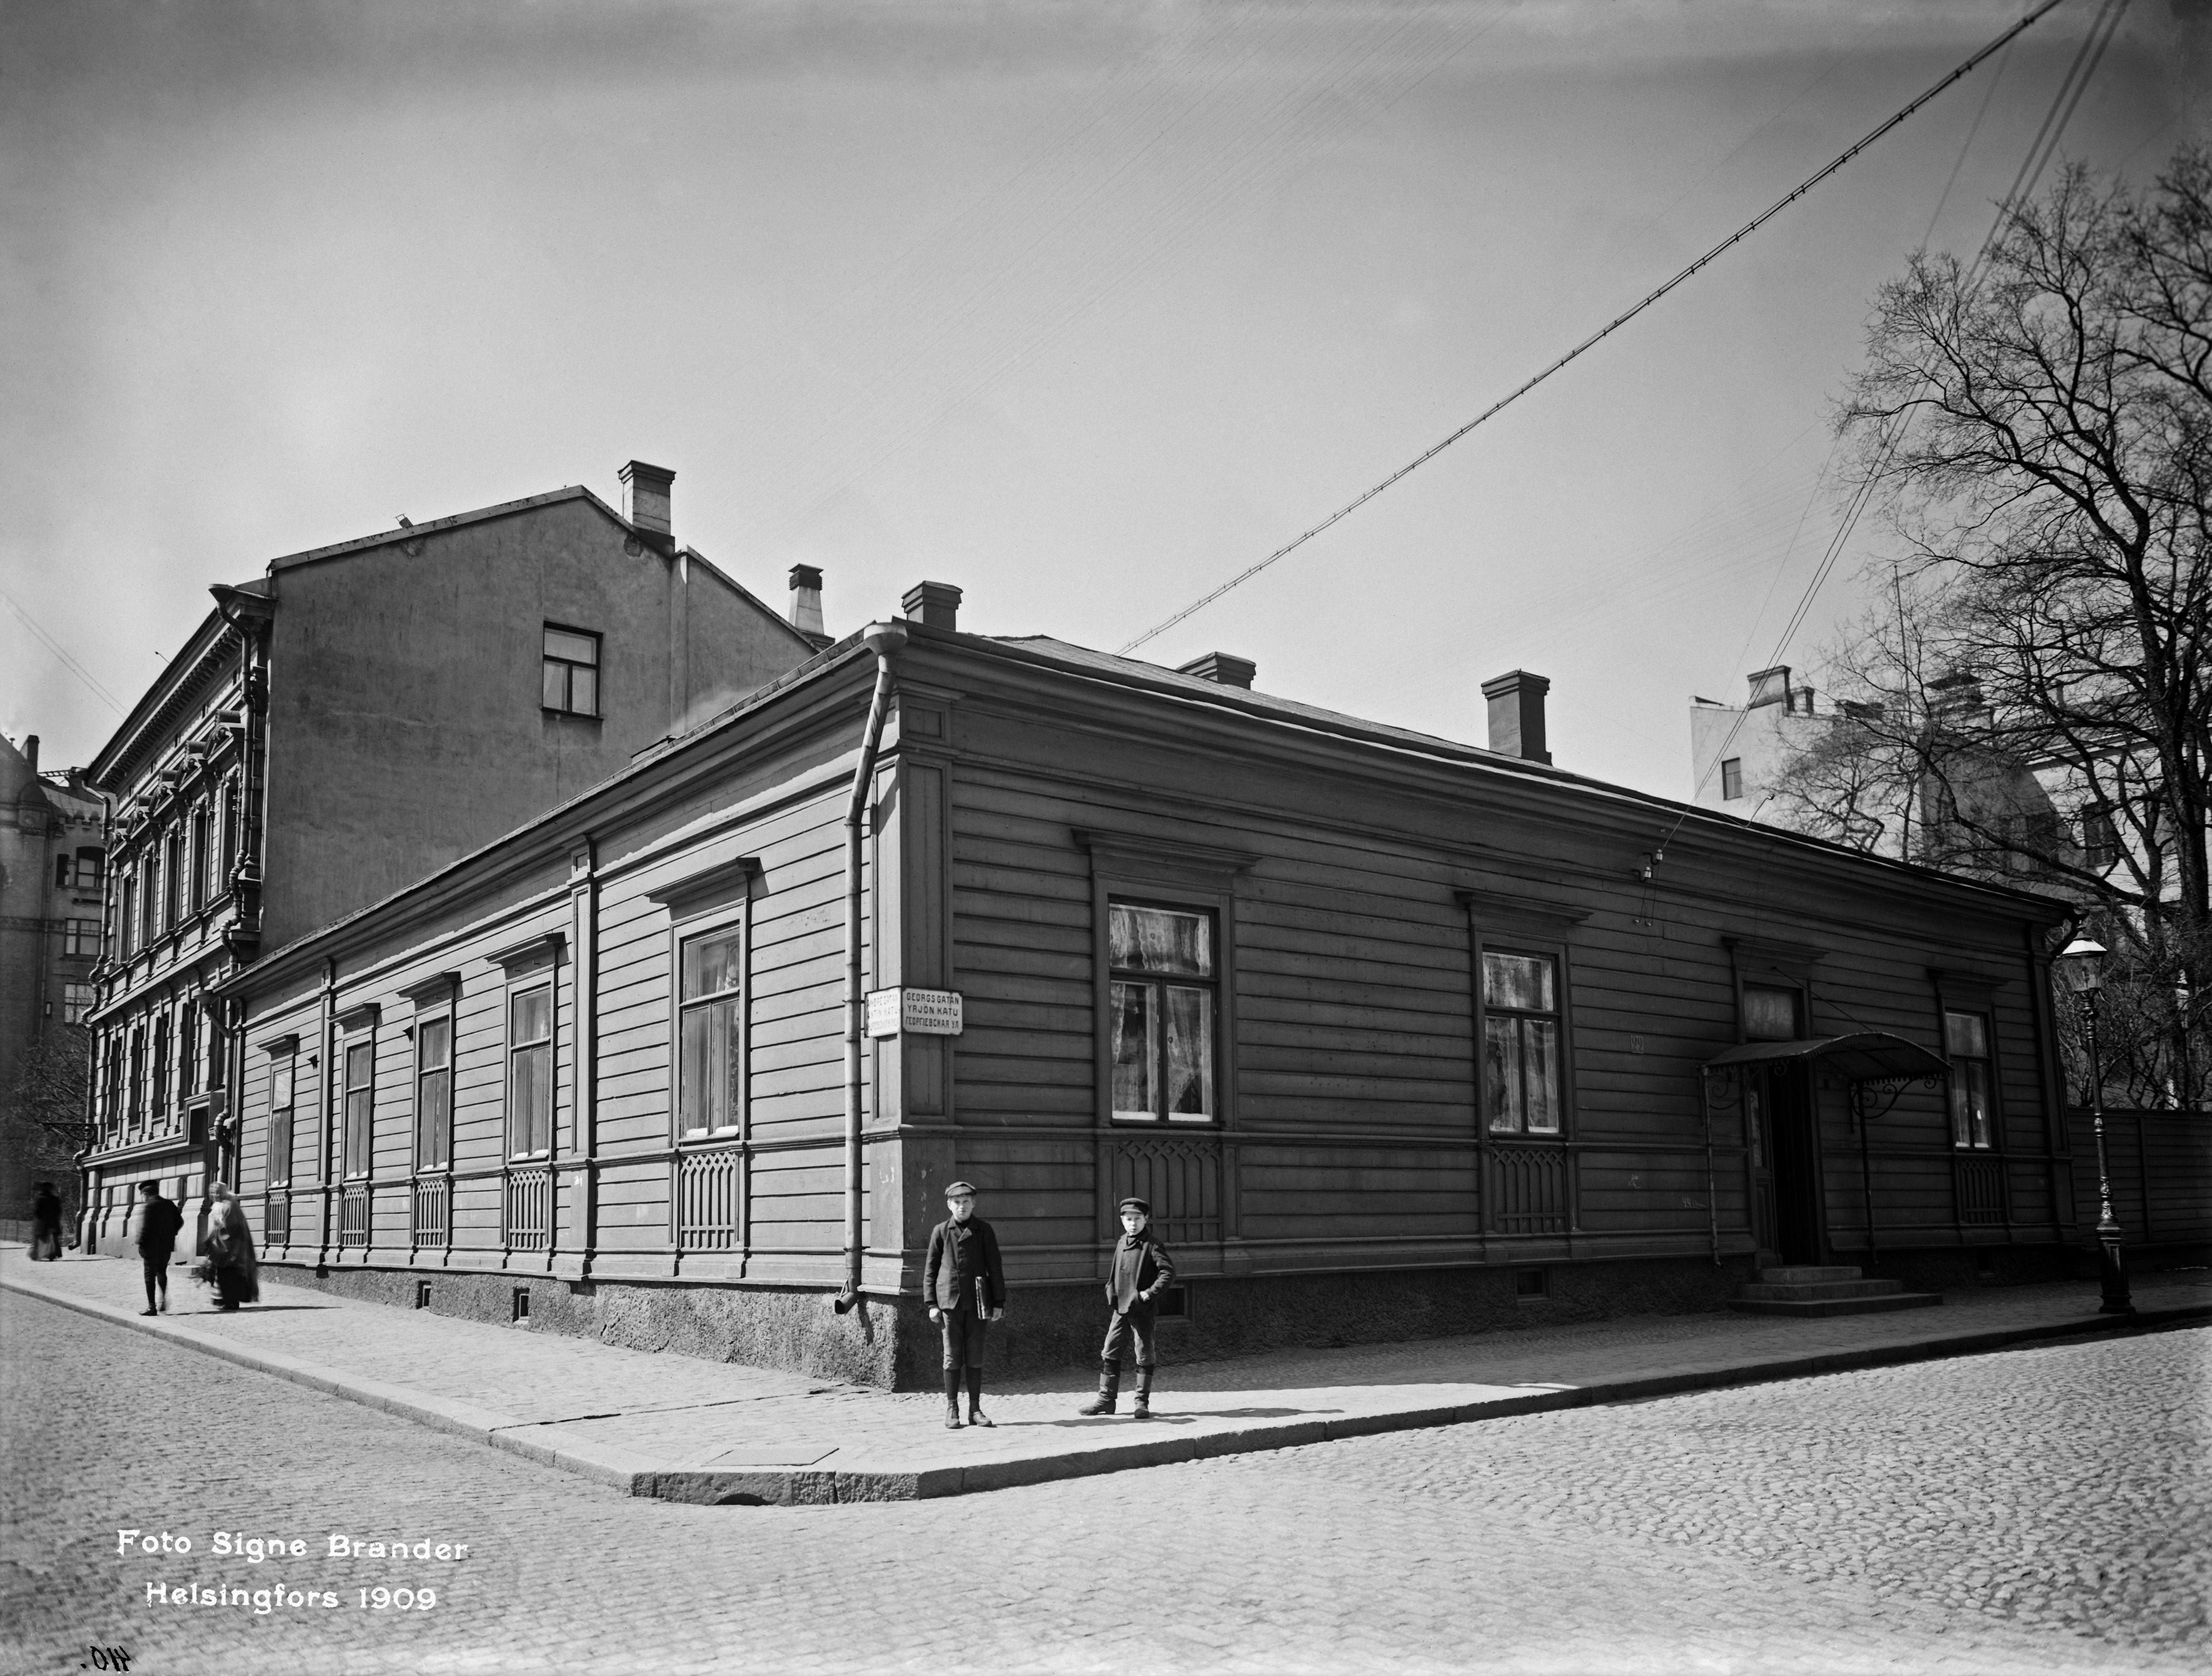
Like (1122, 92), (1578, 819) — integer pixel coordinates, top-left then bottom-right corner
(84, 460), (820, 1240)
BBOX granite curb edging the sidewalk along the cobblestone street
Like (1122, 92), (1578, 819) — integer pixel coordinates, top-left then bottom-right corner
(0, 1274), (2212, 1506)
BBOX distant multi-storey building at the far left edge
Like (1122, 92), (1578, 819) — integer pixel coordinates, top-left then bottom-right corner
(0, 734), (104, 1234)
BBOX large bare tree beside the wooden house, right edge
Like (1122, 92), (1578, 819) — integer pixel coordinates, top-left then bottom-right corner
(1779, 148), (2212, 1105)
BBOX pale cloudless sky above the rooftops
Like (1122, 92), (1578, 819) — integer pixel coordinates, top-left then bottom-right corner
(0, 0), (2212, 796)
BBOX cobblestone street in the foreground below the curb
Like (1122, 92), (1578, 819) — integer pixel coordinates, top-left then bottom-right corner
(0, 1296), (2212, 1672)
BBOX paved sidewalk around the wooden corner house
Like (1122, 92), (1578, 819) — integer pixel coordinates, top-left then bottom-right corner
(0, 1247), (2212, 1504)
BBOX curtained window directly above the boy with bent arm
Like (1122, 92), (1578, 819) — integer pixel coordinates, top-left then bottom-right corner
(1106, 902), (1217, 1123)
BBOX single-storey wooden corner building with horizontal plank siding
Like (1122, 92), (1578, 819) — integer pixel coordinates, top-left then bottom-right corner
(221, 584), (2079, 1384)
